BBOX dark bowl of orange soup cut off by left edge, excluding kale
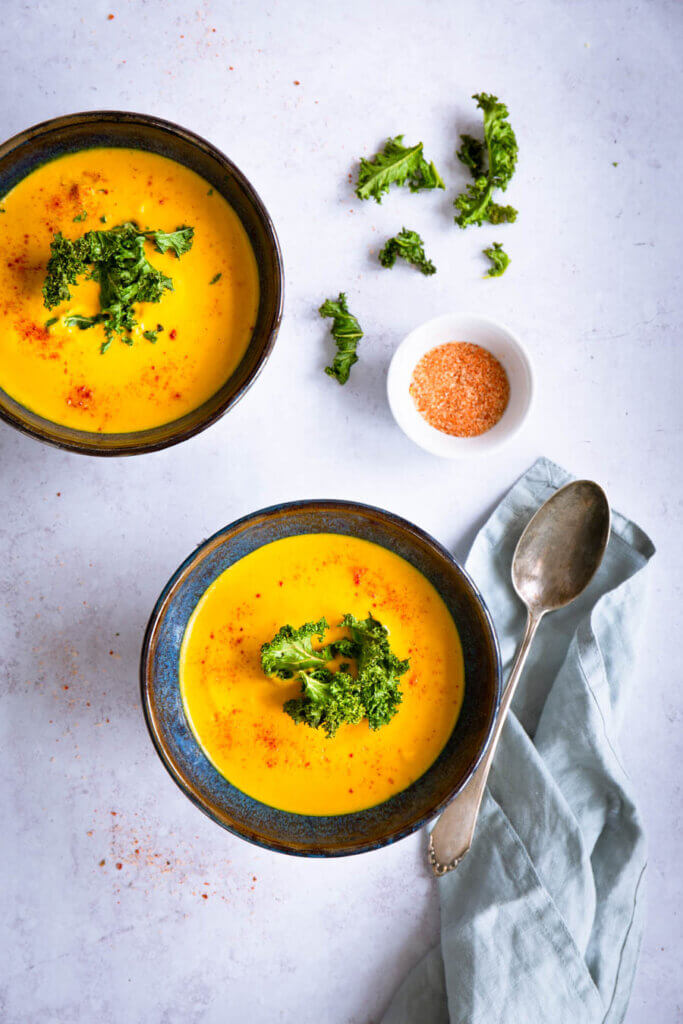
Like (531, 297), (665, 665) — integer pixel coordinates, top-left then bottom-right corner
(0, 111), (283, 456)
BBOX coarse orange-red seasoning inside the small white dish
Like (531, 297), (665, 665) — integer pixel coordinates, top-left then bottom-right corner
(410, 341), (510, 437)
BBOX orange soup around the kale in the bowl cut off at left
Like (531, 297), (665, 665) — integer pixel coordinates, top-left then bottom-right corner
(0, 148), (258, 433)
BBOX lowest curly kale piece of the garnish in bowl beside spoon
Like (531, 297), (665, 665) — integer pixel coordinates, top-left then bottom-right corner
(284, 669), (366, 737)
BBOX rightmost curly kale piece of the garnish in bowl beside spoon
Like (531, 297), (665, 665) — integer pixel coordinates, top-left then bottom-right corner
(342, 614), (410, 729)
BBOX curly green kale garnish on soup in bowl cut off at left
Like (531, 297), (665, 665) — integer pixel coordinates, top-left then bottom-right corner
(43, 221), (194, 352)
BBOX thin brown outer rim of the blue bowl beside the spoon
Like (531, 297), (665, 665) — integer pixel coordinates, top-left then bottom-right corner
(139, 499), (503, 858)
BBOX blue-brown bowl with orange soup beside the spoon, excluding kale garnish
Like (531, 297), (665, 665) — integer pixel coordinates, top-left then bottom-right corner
(141, 501), (501, 857)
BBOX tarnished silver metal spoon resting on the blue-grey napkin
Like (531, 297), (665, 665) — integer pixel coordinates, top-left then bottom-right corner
(429, 480), (609, 874)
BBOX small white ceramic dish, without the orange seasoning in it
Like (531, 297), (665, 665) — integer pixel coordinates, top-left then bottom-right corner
(387, 313), (533, 459)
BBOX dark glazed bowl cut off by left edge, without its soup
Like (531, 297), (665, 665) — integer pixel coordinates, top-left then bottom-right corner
(0, 111), (284, 455)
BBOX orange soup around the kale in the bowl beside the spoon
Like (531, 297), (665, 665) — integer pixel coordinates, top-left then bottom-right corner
(180, 534), (464, 814)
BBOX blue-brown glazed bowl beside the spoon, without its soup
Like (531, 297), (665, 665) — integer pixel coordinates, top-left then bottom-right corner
(140, 501), (501, 857)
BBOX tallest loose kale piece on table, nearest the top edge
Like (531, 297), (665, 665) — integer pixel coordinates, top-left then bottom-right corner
(455, 92), (517, 227)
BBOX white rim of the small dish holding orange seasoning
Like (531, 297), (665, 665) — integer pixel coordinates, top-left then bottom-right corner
(386, 309), (536, 460)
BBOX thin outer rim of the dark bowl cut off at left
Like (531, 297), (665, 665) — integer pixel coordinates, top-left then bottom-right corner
(0, 110), (285, 458)
